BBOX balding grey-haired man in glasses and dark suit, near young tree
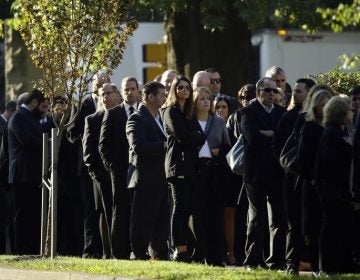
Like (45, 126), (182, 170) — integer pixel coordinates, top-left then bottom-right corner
(83, 83), (120, 258)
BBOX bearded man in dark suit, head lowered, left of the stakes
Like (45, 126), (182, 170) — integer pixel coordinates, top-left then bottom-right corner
(8, 89), (47, 255)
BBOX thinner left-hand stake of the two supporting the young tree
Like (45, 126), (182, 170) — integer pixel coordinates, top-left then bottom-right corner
(40, 133), (49, 256)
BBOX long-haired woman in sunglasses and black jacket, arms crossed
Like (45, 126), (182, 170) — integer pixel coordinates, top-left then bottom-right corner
(163, 75), (206, 262)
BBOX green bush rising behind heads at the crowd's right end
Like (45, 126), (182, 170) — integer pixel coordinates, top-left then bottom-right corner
(310, 67), (360, 94)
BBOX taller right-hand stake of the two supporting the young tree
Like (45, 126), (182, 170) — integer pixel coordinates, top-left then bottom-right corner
(51, 128), (60, 259)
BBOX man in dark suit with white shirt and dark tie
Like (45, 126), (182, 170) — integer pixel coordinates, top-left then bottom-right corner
(99, 77), (138, 259)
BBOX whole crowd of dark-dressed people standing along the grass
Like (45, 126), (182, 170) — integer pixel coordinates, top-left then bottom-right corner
(0, 66), (360, 274)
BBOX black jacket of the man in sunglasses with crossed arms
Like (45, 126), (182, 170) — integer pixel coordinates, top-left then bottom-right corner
(241, 101), (285, 183)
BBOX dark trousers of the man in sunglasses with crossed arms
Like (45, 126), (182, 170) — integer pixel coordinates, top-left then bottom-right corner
(244, 180), (286, 268)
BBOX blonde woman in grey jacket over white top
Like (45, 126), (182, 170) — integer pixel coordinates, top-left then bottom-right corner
(193, 87), (230, 266)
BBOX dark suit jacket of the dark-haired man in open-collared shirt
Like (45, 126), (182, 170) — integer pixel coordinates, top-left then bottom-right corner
(126, 105), (167, 191)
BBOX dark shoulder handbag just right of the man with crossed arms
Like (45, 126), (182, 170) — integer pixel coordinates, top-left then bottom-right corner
(280, 133), (299, 174)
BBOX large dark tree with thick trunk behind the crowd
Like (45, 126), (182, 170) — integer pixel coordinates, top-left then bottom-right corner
(138, 0), (359, 94)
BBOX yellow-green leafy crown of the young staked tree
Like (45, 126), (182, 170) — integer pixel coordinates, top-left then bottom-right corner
(12, 0), (137, 126)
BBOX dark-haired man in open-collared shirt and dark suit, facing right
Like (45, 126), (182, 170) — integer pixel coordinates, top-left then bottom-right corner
(126, 82), (170, 260)
